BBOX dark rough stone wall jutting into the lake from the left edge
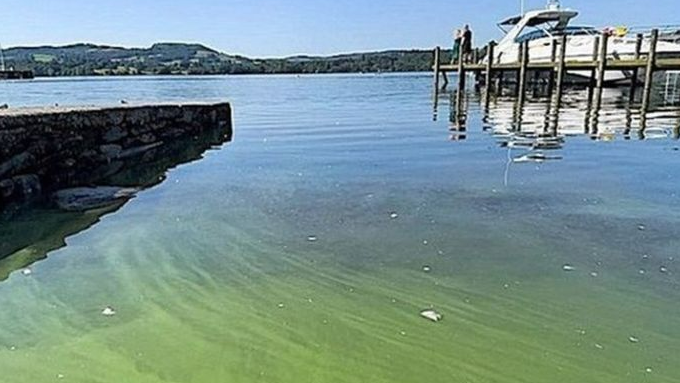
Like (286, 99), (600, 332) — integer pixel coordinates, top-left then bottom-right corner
(0, 103), (232, 206)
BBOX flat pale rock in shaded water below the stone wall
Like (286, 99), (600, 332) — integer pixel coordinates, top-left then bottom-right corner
(52, 186), (139, 211)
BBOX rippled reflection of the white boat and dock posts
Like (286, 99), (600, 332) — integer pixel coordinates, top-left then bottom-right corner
(435, 74), (680, 152)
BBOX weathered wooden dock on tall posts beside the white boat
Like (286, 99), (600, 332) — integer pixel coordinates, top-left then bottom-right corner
(432, 29), (680, 129)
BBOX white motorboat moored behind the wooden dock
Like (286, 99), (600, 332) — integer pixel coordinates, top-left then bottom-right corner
(494, 0), (680, 82)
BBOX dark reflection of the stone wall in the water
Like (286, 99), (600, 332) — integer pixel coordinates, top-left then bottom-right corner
(0, 124), (231, 281)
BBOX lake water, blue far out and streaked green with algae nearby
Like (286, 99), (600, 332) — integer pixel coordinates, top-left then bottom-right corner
(0, 75), (680, 383)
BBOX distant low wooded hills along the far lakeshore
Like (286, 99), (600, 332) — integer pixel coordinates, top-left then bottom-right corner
(4, 43), (440, 76)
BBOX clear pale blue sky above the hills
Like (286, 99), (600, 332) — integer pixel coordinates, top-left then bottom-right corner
(0, 0), (680, 57)
